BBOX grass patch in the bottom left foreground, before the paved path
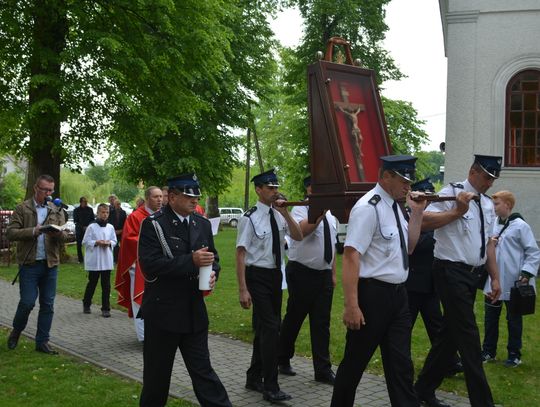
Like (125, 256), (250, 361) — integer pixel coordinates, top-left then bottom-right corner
(0, 329), (194, 407)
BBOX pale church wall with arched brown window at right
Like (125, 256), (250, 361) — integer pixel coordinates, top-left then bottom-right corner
(439, 0), (540, 239)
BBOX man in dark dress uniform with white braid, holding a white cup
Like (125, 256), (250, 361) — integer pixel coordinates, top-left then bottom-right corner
(139, 174), (231, 407)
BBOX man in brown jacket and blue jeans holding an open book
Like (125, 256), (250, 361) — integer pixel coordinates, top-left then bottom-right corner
(7, 175), (66, 355)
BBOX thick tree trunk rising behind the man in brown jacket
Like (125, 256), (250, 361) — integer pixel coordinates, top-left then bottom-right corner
(26, 0), (68, 198)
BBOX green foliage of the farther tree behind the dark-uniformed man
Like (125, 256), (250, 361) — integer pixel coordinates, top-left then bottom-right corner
(113, 0), (280, 196)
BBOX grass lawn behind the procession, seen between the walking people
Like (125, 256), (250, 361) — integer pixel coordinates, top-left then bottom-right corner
(0, 228), (540, 407)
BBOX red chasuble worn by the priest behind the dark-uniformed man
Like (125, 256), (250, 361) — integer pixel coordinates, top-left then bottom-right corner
(114, 205), (150, 318)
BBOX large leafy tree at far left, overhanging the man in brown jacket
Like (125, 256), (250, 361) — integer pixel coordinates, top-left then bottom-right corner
(0, 0), (238, 198)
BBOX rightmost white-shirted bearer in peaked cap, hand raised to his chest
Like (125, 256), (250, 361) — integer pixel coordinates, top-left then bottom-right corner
(415, 155), (502, 407)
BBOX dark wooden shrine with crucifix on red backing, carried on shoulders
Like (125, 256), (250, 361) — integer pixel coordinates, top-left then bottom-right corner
(307, 37), (392, 223)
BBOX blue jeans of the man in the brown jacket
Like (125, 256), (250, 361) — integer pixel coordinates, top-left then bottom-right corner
(13, 262), (58, 345)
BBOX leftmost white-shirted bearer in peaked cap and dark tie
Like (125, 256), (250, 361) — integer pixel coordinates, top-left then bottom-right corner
(236, 169), (302, 402)
